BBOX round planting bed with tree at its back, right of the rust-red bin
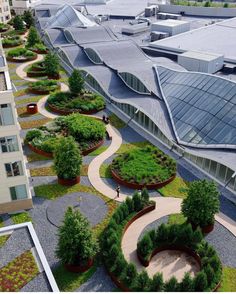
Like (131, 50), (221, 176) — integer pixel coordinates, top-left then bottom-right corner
(47, 91), (105, 115)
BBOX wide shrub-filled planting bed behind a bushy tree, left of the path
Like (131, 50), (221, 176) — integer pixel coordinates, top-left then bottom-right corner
(26, 114), (106, 157)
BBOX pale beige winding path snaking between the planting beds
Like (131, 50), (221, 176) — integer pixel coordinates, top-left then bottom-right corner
(16, 55), (236, 274)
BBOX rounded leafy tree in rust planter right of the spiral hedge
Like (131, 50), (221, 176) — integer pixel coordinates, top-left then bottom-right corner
(181, 180), (220, 227)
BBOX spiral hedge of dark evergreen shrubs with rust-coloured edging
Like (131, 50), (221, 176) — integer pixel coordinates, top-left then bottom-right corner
(101, 193), (222, 292)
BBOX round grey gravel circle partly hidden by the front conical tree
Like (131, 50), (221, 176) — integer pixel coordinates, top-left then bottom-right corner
(47, 193), (108, 227)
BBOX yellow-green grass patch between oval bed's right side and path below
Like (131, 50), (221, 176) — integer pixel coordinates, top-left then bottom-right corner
(158, 177), (188, 198)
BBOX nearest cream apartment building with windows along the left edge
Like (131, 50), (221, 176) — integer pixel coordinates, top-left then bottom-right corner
(0, 44), (32, 214)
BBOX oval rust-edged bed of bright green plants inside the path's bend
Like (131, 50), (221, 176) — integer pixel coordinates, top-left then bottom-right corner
(110, 146), (176, 189)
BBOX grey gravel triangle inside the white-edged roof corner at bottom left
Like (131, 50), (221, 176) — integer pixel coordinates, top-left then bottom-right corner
(20, 272), (52, 292)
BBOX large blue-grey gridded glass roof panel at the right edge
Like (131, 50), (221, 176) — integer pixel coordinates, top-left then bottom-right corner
(157, 67), (236, 146)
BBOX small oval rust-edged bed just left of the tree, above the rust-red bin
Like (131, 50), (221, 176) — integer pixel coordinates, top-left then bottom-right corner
(28, 80), (60, 95)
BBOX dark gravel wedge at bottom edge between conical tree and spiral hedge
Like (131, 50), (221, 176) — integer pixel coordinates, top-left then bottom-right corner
(75, 266), (116, 292)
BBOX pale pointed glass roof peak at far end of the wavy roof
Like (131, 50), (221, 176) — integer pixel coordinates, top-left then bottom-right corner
(43, 4), (97, 28)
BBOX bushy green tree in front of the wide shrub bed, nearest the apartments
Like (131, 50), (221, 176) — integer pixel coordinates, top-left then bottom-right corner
(53, 137), (82, 179)
